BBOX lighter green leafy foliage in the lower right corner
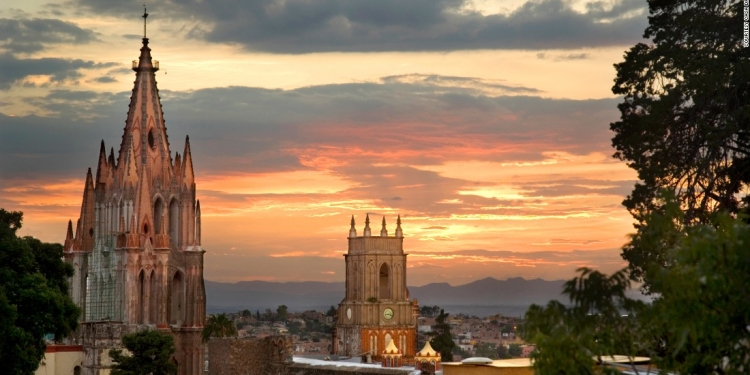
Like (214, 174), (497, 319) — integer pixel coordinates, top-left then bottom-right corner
(527, 203), (750, 374)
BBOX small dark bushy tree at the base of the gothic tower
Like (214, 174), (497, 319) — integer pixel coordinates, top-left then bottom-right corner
(109, 330), (177, 375)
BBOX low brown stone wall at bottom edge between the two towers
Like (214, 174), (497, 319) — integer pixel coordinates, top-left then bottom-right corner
(208, 336), (424, 375)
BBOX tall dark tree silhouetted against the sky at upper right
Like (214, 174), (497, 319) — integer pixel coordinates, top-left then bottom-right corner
(610, 0), (750, 238)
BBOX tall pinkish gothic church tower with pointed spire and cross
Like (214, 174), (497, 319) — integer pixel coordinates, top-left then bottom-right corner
(64, 12), (206, 375)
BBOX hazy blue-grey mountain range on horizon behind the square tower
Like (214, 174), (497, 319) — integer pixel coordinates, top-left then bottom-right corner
(206, 277), (567, 316)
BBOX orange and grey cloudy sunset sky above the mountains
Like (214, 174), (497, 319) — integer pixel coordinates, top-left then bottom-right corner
(0, 0), (648, 285)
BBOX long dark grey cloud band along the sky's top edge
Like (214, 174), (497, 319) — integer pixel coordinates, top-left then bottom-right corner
(81, 0), (647, 54)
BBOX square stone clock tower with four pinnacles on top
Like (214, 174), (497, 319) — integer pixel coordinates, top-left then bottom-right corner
(333, 215), (419, 363)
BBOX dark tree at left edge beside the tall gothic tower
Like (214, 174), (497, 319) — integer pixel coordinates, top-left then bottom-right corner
(0, 209), (80, 374)
